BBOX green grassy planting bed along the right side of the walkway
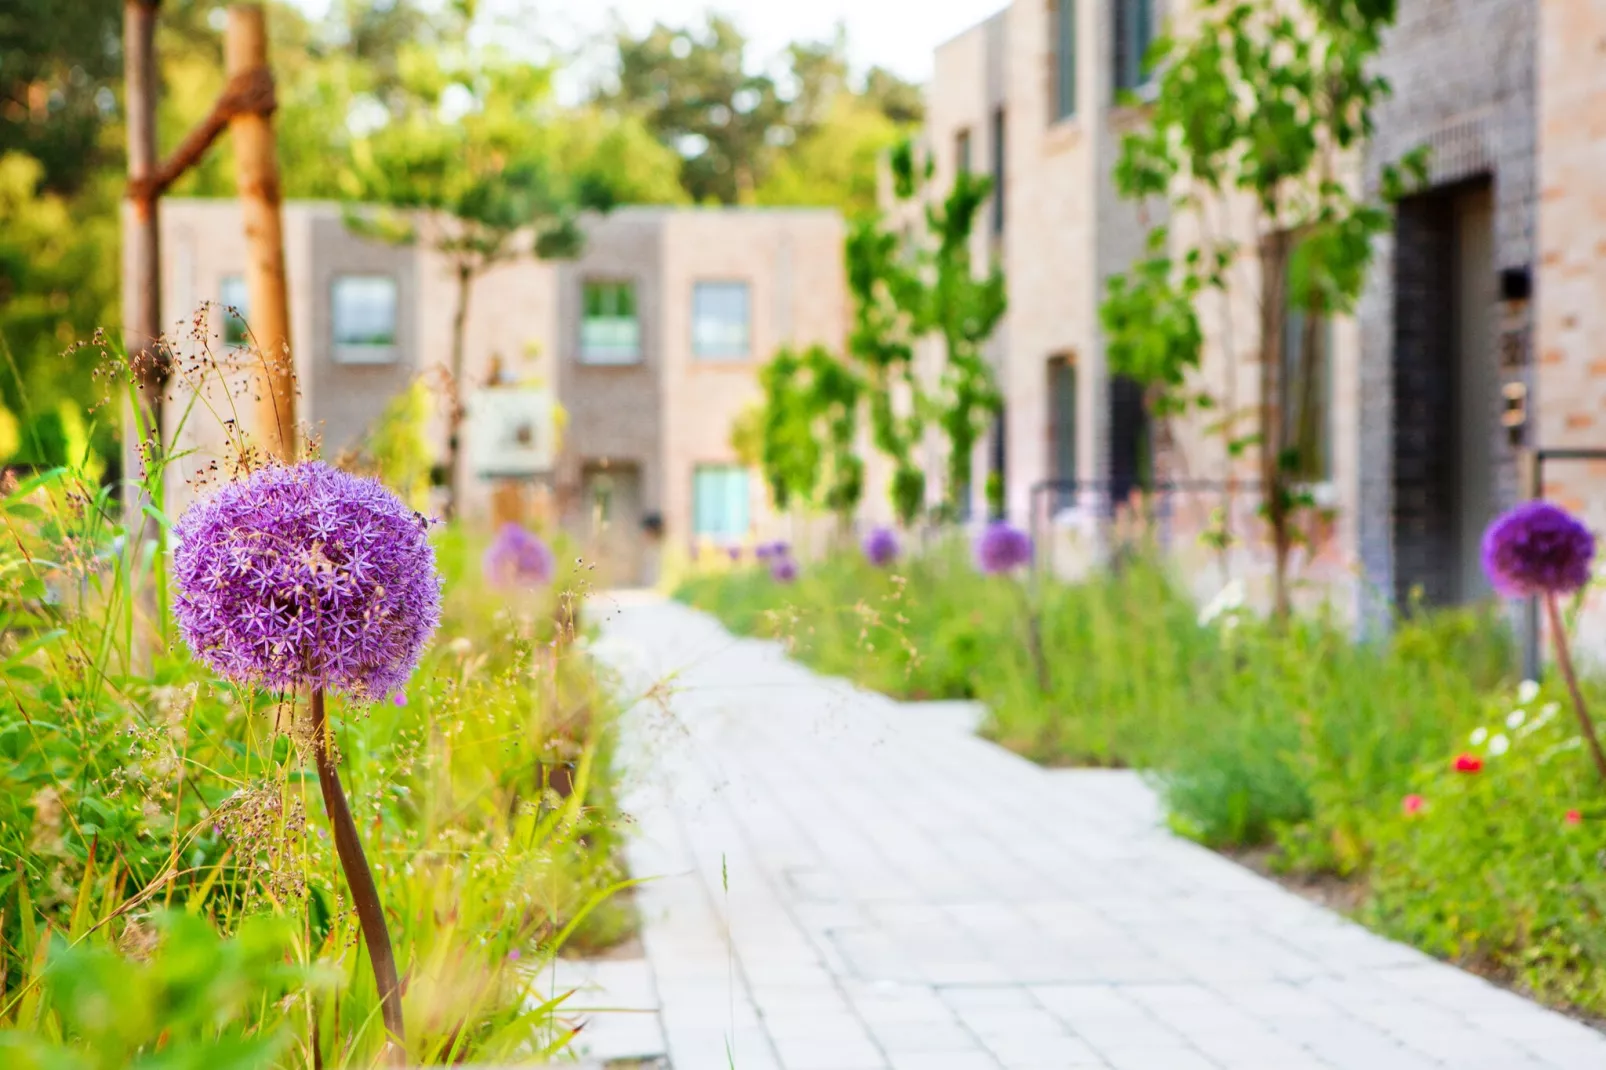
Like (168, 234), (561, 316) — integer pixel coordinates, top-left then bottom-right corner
(679, 545), (1606, 1015)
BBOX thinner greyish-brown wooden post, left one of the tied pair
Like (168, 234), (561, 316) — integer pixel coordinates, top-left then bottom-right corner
(122, 0), (167, 526)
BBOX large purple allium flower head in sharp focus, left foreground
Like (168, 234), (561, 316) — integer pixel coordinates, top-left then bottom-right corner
(173, 461), (440, 697)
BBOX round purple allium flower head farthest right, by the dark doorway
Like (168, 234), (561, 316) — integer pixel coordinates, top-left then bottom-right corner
(1484, 501), (1595, 598)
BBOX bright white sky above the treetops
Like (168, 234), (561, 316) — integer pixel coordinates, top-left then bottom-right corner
(276, 0), (1007, 82)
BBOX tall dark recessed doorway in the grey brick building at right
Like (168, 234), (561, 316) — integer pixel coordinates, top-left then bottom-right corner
(1392, 180), (1498, 607)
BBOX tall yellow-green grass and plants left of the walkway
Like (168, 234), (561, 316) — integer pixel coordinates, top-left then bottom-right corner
(0, 338), (631, 1067)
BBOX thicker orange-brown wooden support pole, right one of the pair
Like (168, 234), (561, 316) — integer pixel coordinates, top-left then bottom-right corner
(223, 3), (297, 461)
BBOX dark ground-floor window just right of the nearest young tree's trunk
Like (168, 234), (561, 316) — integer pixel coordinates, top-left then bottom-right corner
(1278, 257), (1333, 484)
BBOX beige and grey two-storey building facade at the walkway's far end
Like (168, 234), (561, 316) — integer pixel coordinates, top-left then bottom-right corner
(162, 199), (848, 582)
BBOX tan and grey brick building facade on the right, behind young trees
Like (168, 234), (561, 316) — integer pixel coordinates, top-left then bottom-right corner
(925, 0), (1606, 633)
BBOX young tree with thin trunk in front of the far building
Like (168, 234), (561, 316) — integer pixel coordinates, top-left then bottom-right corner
(347, 48), (612, 516)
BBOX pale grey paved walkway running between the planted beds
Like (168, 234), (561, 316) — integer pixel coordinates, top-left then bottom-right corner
(578, 594), (1606, 1070)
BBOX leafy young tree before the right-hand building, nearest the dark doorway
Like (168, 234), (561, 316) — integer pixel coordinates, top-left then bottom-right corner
(1100, 0), (1423, 617)
